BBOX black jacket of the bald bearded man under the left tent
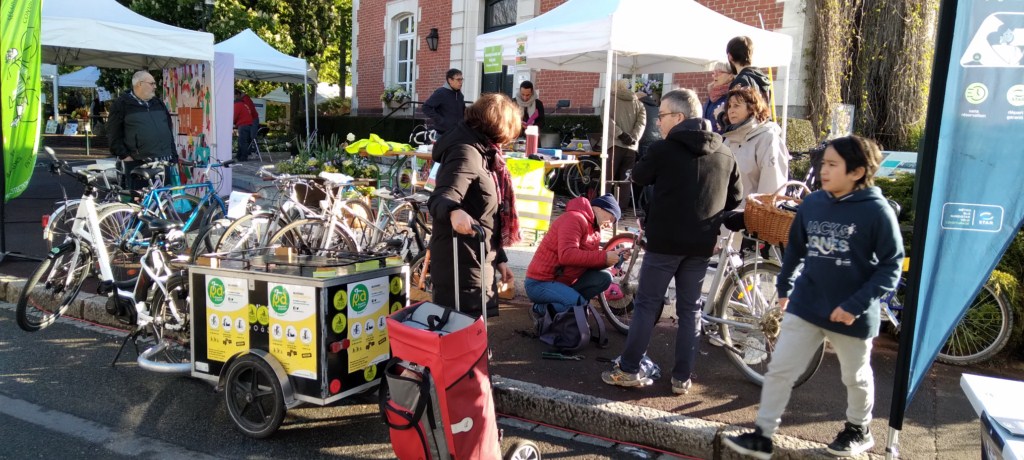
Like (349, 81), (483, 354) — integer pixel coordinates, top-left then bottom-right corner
(106, 91), (174, 160)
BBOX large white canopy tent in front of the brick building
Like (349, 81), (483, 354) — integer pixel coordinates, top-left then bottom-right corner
(476, 0), (793, 194)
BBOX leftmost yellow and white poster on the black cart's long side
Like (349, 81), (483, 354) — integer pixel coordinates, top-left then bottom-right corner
(206, 276), (250, 363)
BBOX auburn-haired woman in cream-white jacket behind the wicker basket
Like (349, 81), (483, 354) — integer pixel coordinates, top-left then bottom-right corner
(722, 88), (790, 207)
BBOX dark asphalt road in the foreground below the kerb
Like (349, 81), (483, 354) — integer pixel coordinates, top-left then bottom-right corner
(0, 303), (688, 459)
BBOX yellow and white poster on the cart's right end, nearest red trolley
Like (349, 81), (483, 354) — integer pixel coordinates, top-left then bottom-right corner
(347, 277), (390, 373)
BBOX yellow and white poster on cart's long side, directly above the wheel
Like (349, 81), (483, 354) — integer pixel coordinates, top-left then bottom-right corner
(266, 283), (318, 379)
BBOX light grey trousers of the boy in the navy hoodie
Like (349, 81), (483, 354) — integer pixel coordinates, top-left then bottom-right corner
(756, 313), (874, 437)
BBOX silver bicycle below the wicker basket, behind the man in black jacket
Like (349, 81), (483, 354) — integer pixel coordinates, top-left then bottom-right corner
(598, 212), (824, 387)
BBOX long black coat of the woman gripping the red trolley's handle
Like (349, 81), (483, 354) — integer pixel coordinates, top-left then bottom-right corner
(427, 119), (508, 316)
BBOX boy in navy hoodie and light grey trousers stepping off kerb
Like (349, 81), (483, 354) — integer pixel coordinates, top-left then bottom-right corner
(725, 136), (903, 459)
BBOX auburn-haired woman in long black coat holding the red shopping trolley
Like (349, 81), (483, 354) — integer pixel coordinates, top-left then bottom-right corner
(427, 93), (521, 317)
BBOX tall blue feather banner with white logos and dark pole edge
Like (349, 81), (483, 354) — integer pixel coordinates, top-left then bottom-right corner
(890, 0), (1024, 420)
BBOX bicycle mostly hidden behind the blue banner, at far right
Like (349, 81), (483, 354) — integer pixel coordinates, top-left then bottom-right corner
(881, 258), (1014, 366)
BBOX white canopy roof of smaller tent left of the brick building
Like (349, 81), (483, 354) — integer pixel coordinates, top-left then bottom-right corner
(214, 29), (316, 84)
